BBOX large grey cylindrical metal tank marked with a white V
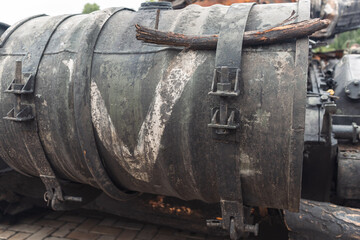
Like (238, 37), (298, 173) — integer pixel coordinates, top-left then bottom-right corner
(0, 1), (309, 209)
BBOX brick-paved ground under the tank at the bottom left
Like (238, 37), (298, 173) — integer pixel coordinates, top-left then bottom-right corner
(0, 209), (226, 240)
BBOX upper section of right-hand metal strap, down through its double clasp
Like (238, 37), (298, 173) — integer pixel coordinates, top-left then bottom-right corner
(208, 3), (254, 135)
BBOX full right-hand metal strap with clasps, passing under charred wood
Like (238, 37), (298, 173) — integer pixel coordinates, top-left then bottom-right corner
(208, 3), (258, 239)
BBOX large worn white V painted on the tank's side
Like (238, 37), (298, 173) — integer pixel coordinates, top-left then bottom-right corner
(91, 51), (206, 182)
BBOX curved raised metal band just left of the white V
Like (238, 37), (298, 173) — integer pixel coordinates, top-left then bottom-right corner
(74, 8), (138, 201)
